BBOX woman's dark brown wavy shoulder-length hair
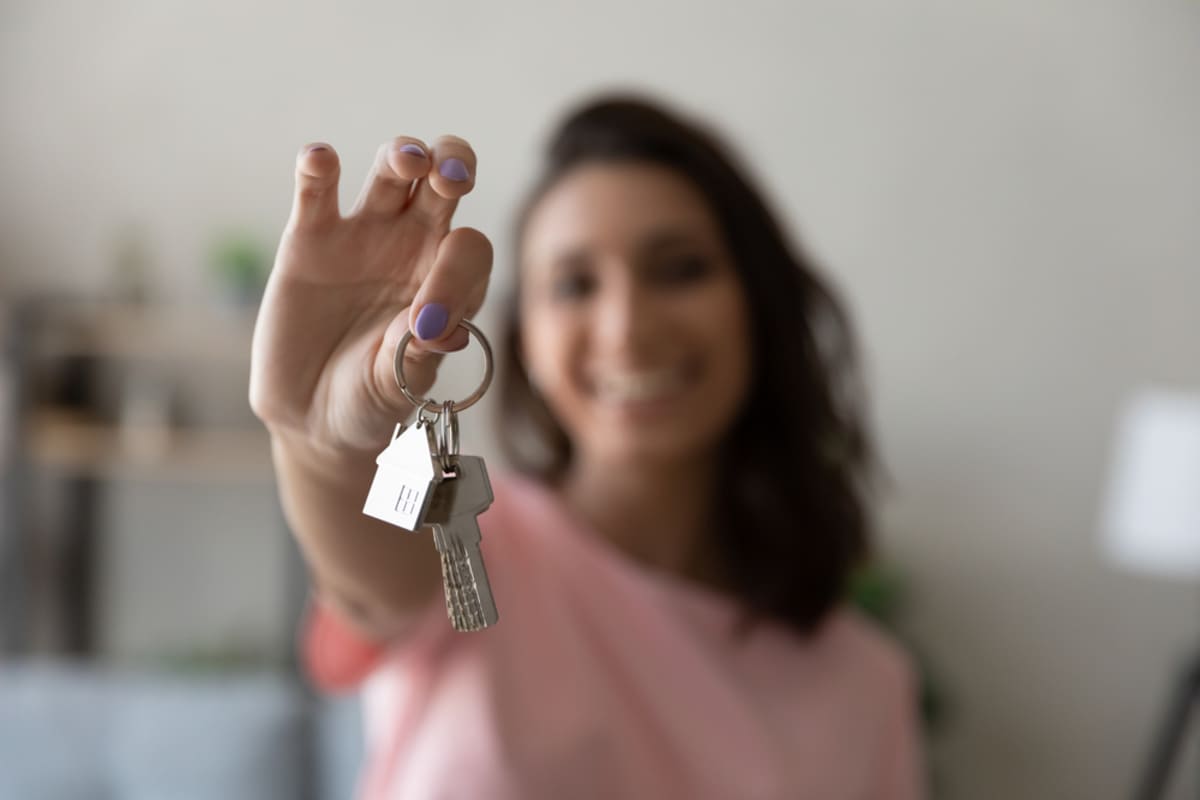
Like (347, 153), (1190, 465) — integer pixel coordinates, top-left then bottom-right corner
(498, 95), (876, 633)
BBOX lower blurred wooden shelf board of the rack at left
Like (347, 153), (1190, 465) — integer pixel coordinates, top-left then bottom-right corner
(29, 410), (274, 482)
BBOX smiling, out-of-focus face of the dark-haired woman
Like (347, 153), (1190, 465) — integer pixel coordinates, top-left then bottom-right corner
(520, 163), (751, 463)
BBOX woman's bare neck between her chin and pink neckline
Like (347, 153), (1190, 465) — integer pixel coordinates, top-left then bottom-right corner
(559, 458), (718, 583)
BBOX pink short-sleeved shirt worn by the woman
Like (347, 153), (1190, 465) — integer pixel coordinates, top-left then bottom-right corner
(306, 477), (924, 800)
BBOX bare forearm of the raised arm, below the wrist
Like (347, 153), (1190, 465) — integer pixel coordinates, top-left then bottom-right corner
(271, 432), (442, 640)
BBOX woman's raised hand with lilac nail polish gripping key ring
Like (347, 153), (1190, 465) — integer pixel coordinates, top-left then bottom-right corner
(250, 137), (492, 457)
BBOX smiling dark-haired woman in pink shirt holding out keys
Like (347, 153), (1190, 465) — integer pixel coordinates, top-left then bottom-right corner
(251, 97), (922, 800)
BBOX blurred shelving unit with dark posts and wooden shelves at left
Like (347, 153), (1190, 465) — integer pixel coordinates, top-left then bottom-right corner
(0, 297), (297, 656)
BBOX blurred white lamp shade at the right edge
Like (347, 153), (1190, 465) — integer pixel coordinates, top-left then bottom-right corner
(1102, 389), (1200, 578)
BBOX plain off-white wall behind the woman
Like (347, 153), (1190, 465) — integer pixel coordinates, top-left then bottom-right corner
(0, 0), (1200, 799)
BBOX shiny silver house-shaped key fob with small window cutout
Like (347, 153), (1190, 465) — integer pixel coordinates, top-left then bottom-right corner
(362, 420), (442, 530)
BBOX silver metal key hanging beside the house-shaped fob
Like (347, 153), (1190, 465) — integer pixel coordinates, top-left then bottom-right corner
(425, 456), (499, 632)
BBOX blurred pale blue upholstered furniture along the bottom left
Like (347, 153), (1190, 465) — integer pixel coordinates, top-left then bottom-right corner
(0, 662), (362, 800)
